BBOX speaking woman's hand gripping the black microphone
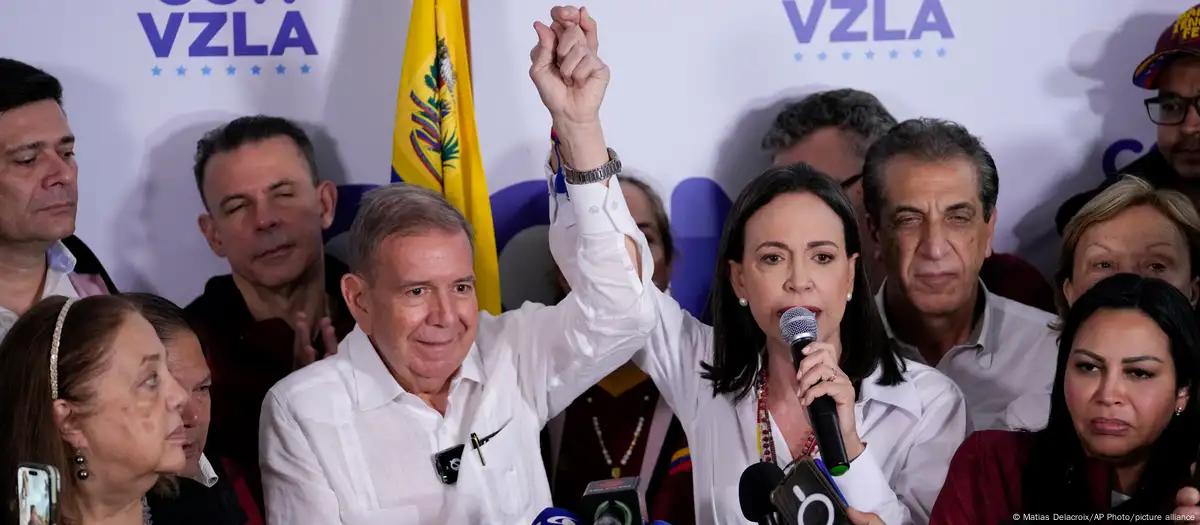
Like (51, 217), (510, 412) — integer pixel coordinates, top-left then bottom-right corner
(796, 342), (864, 460)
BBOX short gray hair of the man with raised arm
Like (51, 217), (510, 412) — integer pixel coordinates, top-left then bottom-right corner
(349, 182), (475, 274)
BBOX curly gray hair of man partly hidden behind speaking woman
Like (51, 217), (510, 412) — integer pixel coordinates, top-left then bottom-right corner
(762, 88), (896, 156)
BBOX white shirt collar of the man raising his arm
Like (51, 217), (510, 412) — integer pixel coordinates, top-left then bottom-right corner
(338, 326), (484, 411)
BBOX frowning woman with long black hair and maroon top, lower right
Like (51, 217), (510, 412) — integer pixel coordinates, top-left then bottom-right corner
(931, 273), (1200, 525)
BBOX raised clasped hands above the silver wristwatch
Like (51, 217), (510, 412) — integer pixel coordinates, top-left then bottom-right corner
(529, 6), (608, 132)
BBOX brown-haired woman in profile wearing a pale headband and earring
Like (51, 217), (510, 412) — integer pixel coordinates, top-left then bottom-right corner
(0, 296), (187, 525)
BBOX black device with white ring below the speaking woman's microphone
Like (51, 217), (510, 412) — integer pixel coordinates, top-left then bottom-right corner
(770, 458), (851, 525)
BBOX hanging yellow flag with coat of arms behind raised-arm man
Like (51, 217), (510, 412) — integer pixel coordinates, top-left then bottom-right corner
(391, 0), (500, 314)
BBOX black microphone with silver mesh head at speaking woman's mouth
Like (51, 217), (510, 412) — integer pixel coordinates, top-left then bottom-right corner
(779, 307), (850, 476)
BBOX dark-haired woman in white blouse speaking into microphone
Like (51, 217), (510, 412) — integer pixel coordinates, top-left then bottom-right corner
(619, 164), (967, 525)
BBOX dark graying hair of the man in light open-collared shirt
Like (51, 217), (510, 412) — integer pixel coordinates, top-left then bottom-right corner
(863, 119), (1000, 224)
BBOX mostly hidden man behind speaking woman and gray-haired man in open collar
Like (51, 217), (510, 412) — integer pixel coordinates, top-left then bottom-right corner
(762, 89), (1055, 312)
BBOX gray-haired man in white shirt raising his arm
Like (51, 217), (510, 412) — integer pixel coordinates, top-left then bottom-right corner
(259, 6), (658, 525)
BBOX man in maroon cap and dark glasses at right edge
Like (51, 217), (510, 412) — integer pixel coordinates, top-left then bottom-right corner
(1055, 5), (1200, 234)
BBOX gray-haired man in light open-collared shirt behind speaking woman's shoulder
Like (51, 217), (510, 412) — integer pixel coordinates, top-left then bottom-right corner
(863, 119), (1057, 430)
